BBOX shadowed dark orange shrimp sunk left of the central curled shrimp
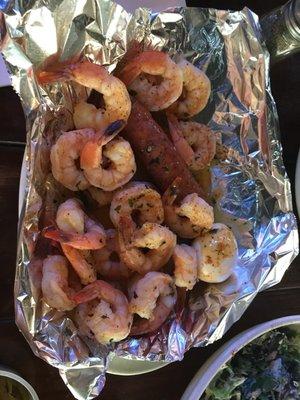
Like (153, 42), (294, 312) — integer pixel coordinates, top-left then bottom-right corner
(93, 229), (131, 281)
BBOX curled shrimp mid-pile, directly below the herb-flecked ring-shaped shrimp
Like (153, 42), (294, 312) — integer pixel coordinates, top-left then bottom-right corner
(119, 219), (176, 275)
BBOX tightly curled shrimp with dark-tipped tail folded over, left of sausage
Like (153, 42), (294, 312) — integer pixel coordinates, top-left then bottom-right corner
(80, 135), (136, 191)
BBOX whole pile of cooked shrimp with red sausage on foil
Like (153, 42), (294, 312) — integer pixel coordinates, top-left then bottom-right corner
(37, 51), (237, 344)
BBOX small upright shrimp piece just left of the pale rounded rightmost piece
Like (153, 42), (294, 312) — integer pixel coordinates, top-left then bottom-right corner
(173, 244), (197, 290)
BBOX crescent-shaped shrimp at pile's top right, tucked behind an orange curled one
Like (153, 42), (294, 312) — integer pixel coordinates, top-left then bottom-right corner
(170, 60), (211, 118)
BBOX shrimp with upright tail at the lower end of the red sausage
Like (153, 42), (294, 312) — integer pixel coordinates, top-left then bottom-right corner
(162, 178), (214, 239)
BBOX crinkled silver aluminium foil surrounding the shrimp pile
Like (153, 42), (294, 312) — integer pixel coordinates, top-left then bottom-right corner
(0, 0), (298, 400)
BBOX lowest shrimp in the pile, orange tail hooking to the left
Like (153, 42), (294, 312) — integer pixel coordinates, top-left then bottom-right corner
(74, 280), (132, 344)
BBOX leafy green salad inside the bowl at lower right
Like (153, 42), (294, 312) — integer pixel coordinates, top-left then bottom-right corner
(200, 328), (300, 400)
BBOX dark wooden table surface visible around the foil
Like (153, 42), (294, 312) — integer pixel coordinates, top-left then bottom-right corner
(0, 0), (300, 400)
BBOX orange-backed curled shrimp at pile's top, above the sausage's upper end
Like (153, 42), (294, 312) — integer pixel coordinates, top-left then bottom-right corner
(120, 51), (182, 111)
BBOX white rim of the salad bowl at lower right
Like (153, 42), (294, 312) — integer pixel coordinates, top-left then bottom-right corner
(181, 315), (300, 400)
